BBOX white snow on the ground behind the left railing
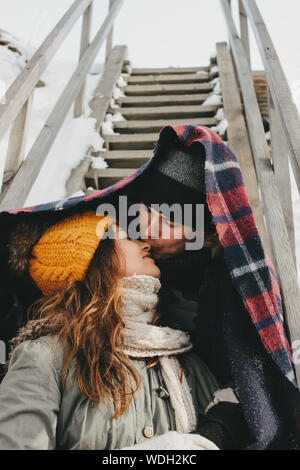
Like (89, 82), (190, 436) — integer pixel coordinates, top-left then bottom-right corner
(0, 32), (104, 207)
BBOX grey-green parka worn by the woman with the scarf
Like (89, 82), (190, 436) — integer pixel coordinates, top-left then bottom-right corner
(0, 335), (218, 450)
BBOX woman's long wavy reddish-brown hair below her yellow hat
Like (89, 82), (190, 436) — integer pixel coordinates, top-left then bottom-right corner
(9, 237), (140, 419)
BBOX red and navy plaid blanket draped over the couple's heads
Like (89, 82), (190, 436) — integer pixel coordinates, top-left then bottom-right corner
(0, 125), (299, 448)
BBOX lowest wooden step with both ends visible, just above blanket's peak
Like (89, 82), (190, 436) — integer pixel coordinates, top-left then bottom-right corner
(113, 117), (218, 134)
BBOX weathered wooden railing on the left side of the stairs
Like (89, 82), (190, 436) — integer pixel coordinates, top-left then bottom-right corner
(0, 0), (124, 210)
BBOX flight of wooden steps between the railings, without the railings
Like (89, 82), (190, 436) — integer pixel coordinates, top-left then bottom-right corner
(85, 64), (221, 192)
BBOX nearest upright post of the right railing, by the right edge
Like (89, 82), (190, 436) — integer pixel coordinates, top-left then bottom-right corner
(268, 88), (297, 269)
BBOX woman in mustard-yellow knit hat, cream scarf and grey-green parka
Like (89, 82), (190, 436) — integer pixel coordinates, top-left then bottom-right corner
(0, 212), (244, 449)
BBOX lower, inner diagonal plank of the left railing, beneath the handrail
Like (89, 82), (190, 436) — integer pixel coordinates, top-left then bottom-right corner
(1, 0), (123, 210)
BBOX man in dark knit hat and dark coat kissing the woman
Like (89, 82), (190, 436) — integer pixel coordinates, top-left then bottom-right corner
(132, 144), (250, 449)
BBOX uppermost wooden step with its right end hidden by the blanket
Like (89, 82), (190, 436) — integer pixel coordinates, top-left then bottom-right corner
(104, 133), (158, 150)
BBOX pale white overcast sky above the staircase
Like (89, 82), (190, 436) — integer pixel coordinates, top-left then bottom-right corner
(0, 0), (300, 83)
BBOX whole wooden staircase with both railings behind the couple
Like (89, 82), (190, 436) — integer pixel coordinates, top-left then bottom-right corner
(0, 0), (300, 384)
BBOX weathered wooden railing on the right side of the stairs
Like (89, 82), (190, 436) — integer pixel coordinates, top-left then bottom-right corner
(220, 0), (300, 384)
